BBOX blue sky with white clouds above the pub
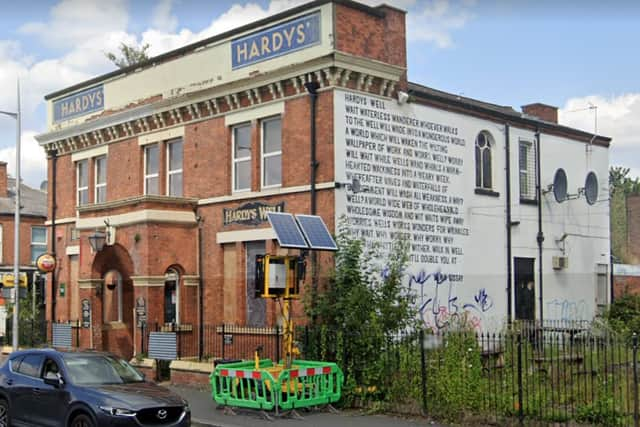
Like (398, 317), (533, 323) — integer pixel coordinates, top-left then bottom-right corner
(0, 0), (640, 186)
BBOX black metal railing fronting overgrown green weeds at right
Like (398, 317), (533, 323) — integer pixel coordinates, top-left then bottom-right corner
(300, 322), (640, 426)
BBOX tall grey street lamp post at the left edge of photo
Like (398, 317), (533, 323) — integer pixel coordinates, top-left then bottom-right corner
(0, 80), (21, 351)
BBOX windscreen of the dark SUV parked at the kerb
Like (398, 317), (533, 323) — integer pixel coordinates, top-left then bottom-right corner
(62, 353), (144, 385)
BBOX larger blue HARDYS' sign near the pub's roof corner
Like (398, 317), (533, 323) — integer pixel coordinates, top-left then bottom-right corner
(231, 12), (320, 70)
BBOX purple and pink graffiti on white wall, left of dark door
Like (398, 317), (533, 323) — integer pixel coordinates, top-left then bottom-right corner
(409, 269), (493, 332)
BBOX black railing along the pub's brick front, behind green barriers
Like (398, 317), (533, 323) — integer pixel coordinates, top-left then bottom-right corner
(139, 323), (283, 360)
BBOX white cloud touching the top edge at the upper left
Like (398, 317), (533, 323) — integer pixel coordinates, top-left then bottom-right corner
(20, 0), (129, 48)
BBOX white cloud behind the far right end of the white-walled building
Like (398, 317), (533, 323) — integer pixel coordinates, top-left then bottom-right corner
(559, 93), (640, 180)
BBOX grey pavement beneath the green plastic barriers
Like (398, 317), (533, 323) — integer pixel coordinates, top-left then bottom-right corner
(168, 386), (443, 427)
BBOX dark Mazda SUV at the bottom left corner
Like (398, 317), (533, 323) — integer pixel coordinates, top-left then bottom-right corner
(0, 349), (191, 427)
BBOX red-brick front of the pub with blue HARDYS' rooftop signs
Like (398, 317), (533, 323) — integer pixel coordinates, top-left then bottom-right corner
(38, 0), (609, 356)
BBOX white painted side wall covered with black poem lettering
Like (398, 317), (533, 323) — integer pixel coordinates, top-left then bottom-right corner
(334, 91), (609, 329)
